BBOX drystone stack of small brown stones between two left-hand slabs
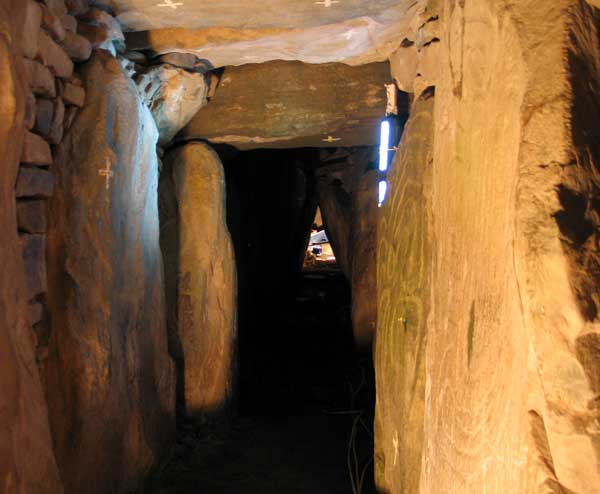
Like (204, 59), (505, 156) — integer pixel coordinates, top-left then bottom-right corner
(15, 0), (123, 353)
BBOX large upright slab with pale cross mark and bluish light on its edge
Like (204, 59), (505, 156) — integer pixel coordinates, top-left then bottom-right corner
(42, 51), (175, 493)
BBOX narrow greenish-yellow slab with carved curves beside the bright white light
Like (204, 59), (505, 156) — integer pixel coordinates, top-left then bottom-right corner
(374, 90), (434, 493)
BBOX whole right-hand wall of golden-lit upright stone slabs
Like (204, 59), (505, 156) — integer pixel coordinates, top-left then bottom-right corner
(376, 0), (600, 494)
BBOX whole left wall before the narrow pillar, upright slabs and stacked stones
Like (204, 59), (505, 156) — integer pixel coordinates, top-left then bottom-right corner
(0, 0), (174, 494)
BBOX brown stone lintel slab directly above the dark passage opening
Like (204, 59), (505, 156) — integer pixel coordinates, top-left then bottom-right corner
(181, 62), (390, 149)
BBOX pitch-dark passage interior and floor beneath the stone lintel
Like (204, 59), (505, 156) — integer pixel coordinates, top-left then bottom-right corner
(153, 148), (375, 494)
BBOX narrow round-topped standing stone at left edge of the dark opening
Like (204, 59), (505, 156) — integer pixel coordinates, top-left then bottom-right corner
(161, 143), (237, 417)
